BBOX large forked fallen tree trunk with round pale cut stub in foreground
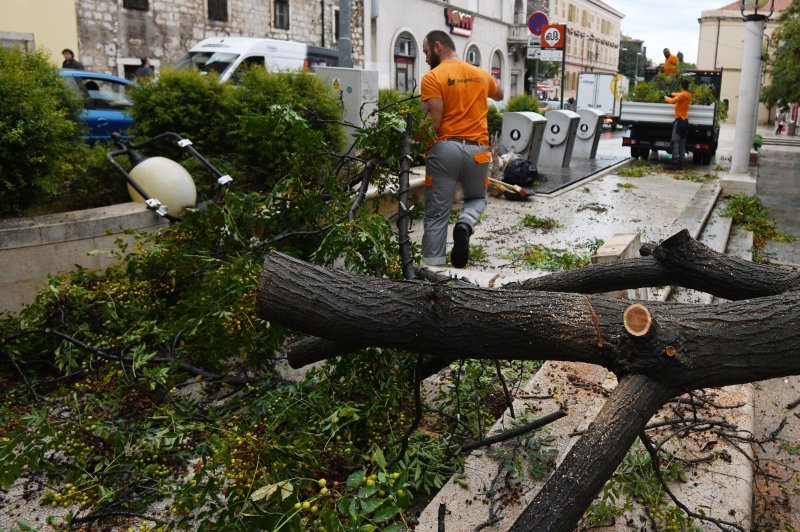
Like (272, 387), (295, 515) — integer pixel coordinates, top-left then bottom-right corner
(256, 235), (800, 530)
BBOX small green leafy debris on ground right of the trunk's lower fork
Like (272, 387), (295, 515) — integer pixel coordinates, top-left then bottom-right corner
(581, 440), (699, 531)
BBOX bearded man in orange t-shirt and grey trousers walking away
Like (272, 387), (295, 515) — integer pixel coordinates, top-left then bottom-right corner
(421, 30), (503, 268)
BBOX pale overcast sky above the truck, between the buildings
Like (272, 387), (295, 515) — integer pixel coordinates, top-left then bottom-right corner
(603, 0), (731, 63)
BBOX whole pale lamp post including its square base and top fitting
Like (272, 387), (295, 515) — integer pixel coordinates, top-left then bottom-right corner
(731, 0), (775, 183)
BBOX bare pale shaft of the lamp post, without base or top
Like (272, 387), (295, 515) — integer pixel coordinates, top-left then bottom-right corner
(731, 15), (766, 174)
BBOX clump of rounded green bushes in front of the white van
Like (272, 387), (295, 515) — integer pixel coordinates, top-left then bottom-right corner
(131, 68), (344, 190)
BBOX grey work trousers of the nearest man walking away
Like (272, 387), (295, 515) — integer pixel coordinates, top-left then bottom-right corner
(422, 140), (491, 266)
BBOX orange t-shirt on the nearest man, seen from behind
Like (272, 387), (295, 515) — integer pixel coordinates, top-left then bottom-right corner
(421, 60), (497, 146)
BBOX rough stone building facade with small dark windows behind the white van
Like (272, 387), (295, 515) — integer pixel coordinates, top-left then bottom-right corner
(75, 0), (364, 77)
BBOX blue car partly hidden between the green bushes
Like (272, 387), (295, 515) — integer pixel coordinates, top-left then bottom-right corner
(59, 69), (135, 143)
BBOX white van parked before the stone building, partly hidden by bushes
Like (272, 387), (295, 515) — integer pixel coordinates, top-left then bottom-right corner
(175, 37), (339, 82)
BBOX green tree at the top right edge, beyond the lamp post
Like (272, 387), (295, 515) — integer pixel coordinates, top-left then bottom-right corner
(761, 2), (800, 106)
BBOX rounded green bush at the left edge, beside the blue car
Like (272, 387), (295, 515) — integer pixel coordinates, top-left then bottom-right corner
(0, 47), (82, 216)
